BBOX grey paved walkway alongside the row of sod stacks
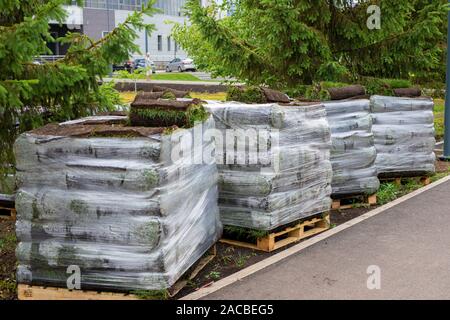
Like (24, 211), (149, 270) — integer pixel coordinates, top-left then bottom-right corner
(205, 181), (450, 299)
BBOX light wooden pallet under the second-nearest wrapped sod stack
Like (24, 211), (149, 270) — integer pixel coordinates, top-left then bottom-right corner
(220, 213), (330, 252)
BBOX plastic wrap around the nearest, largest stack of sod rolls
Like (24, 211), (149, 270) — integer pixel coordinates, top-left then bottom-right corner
(15, 118), (222, 291)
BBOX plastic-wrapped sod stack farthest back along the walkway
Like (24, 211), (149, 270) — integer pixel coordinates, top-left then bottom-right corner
(370, 96), (436, 176)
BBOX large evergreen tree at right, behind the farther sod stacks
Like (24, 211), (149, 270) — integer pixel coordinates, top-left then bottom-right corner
(174, 0), (447, 89)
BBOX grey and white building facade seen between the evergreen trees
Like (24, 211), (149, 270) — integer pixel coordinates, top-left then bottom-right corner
(49, 0), (188, 68)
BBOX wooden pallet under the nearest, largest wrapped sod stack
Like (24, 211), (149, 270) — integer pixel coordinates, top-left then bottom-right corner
(17, 245), (217, 300)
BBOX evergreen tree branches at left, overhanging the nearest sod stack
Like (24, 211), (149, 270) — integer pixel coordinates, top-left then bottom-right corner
(0, 0), (155, 182)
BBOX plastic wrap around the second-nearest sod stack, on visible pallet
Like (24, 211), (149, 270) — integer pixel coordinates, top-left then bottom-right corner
(206, 102), (332, 230)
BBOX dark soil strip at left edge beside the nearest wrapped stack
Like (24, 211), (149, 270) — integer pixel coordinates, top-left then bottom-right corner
(0, 219), (17, 300)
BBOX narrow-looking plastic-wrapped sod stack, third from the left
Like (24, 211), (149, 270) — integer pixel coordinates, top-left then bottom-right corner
(325, 99), (380, 197)
